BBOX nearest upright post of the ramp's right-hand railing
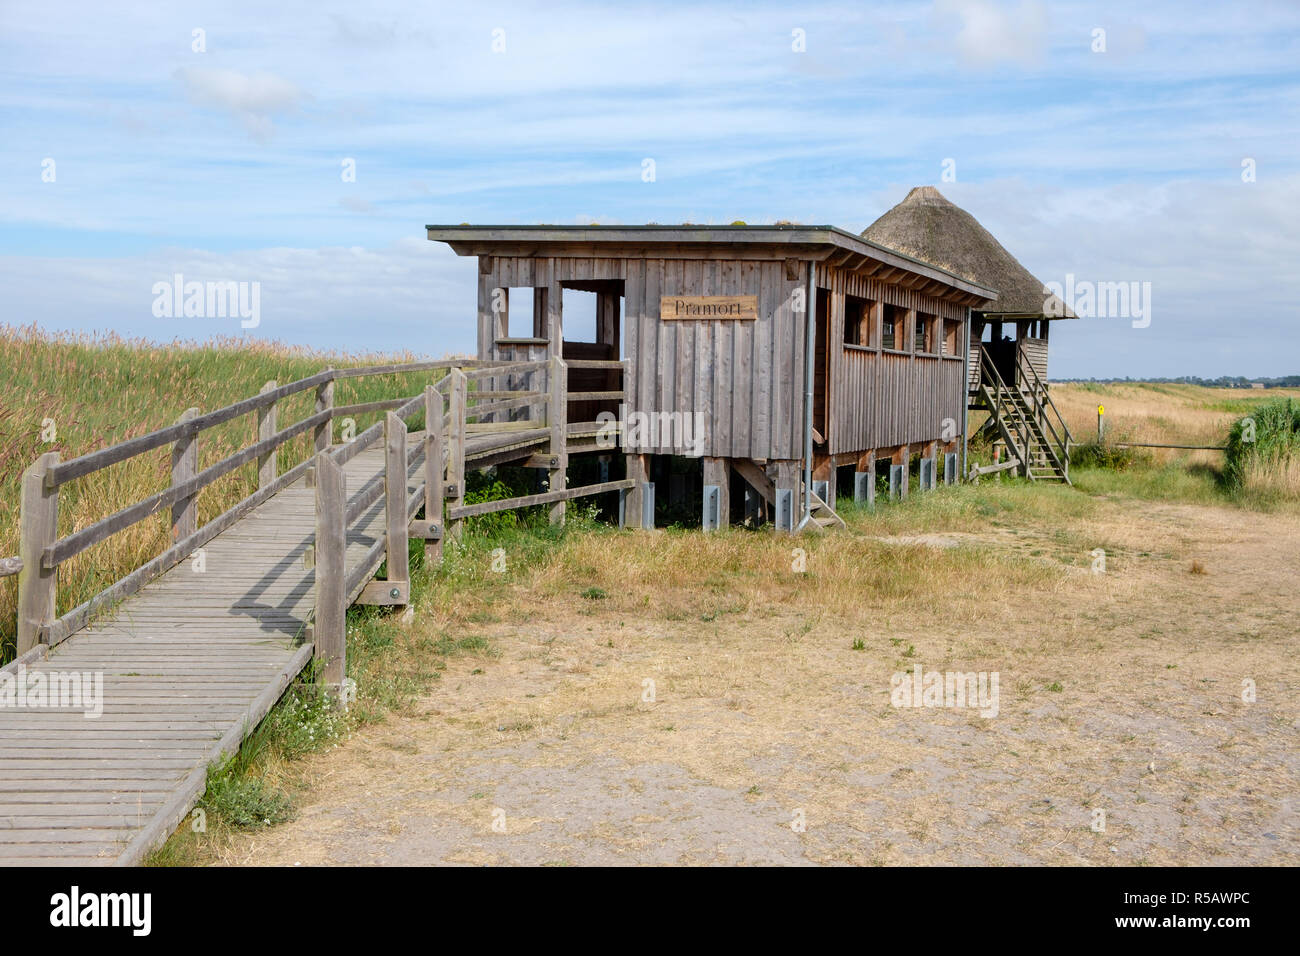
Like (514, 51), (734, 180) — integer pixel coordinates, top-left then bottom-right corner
(312, 454), (347, 705)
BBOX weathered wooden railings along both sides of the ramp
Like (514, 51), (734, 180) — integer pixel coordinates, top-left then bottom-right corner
(8, 358), (633, 685)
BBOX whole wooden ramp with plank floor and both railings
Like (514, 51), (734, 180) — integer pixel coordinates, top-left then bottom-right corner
(0, 358), (633, 865)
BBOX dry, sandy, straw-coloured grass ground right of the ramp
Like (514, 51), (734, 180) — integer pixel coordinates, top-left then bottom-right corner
(172, 483), (1300, 864)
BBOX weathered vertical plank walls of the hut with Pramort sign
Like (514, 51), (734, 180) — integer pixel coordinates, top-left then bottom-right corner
(478, 256), (966, 459)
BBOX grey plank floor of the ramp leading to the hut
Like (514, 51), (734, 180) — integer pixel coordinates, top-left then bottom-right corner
(0, 442), (421, 865)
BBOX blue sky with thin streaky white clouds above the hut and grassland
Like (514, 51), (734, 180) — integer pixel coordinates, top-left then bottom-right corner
(0, 0), (1300, 377)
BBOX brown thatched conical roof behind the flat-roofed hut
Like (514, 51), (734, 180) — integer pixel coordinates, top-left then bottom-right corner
(862, 186), (1078, 319)
